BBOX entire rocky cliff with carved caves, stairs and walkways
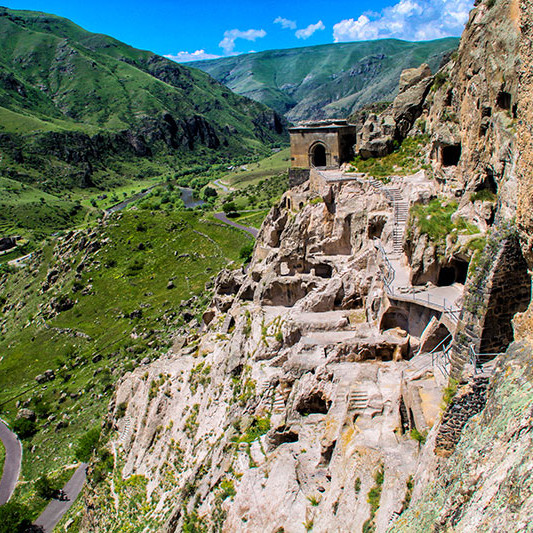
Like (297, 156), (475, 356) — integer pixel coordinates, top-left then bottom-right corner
(77, 0), (533, 533)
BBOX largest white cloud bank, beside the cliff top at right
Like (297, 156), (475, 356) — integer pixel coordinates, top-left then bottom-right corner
(333, 0), (473, 43)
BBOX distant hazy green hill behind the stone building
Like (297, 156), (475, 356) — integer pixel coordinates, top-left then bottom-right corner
(188, 37), (459, 121)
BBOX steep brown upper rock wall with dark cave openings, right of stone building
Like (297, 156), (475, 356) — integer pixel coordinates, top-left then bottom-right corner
(425, 0), (520, 212)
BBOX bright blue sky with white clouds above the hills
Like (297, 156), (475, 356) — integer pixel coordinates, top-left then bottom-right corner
(4, 0), (473, 62)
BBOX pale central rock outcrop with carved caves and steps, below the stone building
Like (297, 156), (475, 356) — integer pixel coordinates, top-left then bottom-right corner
(81, 181), (444, 532)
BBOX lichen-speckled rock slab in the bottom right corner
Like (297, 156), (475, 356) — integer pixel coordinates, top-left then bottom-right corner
(390, 343), (533, 533)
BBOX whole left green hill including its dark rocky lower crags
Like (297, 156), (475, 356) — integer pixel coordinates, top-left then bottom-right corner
(0, 8), (286, 190)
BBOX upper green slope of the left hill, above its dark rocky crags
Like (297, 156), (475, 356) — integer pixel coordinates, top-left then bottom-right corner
(0, 10), (282, 142)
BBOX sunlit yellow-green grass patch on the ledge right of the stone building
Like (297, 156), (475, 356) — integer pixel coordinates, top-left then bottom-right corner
(352, 135), (429, 179)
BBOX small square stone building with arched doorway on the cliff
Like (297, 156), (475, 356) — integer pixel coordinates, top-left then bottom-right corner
(289, 120), (356, 187)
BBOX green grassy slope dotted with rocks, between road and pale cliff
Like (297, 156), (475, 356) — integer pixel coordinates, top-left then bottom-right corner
(0, 210), (248, 512)
